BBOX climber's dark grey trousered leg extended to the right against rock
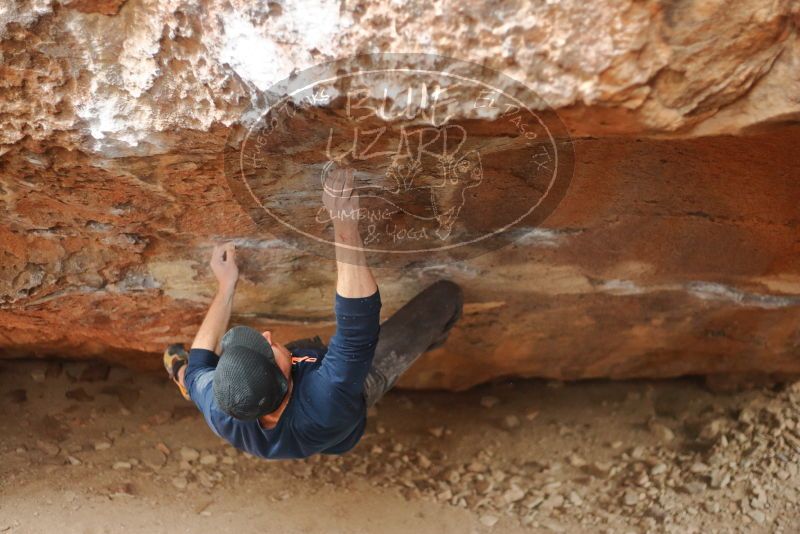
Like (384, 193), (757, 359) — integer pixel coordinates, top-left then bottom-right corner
(364, 280), (463, 406)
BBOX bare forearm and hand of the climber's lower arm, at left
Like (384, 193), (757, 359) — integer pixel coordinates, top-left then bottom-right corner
(192, 243), (239, 354)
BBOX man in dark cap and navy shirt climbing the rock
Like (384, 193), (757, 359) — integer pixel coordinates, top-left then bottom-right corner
(164, 170), (462, 459)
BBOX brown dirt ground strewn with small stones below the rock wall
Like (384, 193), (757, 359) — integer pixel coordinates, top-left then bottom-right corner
(0, 361), (800, 534)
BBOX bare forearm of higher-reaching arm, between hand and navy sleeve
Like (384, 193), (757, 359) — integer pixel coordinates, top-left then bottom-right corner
(333, 221), (378, 298)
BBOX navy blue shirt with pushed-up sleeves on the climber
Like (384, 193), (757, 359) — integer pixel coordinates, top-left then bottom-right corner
(184, 291), (381, 459)
